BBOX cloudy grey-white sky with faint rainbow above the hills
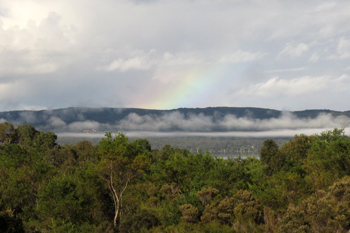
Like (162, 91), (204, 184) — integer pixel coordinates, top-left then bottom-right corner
(0, 0), (350, 111)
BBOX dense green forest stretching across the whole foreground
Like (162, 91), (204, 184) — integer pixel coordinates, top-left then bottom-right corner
(0, 122), (350, 232)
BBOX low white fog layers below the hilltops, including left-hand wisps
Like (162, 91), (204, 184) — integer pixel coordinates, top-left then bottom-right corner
(0, 109), (350, 138)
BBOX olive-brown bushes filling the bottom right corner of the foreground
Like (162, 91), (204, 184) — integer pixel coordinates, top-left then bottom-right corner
(279, 176), (350, 232)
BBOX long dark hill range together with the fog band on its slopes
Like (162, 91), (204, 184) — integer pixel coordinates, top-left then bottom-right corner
(0, 107), (350, 133)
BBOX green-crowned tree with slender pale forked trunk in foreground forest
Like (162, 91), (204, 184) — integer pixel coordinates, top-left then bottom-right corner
(97, 132), (148, 227)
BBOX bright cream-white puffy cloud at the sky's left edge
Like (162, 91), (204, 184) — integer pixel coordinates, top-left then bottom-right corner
(0, 12), (75, 77)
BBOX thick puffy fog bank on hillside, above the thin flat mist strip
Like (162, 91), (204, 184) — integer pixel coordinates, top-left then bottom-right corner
(116, 112), (350, 132)
